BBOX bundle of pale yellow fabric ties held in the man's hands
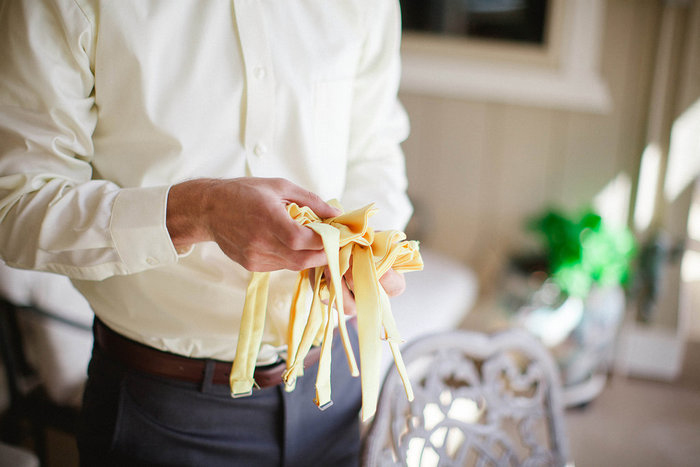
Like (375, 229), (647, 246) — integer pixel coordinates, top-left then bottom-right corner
(230, 201), (423, 420)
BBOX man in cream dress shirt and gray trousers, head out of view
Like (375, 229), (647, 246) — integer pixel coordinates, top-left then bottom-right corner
(0, 0), (410, 466)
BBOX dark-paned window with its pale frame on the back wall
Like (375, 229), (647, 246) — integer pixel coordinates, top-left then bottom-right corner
(401, 0), (611, 113)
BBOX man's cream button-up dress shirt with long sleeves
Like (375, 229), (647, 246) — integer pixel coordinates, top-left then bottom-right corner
(0, 0), (410, 361)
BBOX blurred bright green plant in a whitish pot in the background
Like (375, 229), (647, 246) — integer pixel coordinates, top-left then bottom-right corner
(511, 209), (637, 405)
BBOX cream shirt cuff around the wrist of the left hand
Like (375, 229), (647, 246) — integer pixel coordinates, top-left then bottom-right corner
(110, 186), (178, 274)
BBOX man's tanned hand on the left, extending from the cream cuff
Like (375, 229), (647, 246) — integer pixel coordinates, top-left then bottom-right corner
(166, 177), (340, 272)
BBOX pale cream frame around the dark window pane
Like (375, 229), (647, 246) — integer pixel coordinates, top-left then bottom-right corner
(401, 0), (612, 113)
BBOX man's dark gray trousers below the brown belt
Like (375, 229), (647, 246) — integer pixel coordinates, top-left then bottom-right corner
(78, 326), (361, 467)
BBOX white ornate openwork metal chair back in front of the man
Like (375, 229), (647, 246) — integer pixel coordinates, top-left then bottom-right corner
(363, 329), (568, 467)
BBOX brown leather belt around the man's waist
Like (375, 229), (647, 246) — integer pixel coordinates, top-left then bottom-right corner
(94, 319), (321, 388)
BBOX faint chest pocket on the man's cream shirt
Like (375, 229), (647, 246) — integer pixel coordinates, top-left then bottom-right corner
(313, 79), (353, 164)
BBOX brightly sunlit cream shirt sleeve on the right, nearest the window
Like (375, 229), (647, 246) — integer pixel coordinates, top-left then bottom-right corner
(343, 0), (412, 229)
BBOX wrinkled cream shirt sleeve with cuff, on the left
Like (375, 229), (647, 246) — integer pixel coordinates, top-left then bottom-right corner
(0, 0), (177, 280)
